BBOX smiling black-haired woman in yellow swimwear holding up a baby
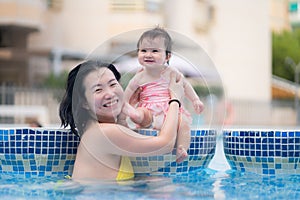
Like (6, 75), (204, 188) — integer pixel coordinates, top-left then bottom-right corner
(60, 61), (184, 181)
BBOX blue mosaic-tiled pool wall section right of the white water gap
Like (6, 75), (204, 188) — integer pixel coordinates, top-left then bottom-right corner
(223, 129), (300, 175)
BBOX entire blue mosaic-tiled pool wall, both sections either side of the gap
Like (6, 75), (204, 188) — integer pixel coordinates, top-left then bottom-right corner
(0, 128), (300, 177)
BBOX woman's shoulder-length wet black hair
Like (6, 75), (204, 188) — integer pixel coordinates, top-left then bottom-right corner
(59, 60), (121, 136)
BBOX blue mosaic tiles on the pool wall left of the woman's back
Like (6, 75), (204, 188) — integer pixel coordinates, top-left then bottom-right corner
(0, 129), (79, 177)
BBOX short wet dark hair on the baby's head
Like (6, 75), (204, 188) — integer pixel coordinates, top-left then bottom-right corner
(137, 27), (173, 56)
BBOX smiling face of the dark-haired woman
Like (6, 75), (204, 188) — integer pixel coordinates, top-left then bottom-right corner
(83, 67), (124, 122)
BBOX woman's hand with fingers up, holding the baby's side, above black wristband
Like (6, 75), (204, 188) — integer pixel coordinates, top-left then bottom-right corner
(169, 72), (184, 101)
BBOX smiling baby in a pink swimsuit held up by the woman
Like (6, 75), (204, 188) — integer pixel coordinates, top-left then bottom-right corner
(120, 27), (204, 163)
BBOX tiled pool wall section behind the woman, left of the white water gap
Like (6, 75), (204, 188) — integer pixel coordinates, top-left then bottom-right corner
(0, 128), (217, 177)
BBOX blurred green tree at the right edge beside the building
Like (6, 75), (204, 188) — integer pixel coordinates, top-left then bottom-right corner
(272, 29), (300, 81)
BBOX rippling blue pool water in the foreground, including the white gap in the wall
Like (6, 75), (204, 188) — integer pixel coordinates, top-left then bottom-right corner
(0, 139), (300, 200)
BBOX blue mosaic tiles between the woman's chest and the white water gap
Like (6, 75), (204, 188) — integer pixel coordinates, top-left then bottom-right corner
(131, 130), (216, 176)
